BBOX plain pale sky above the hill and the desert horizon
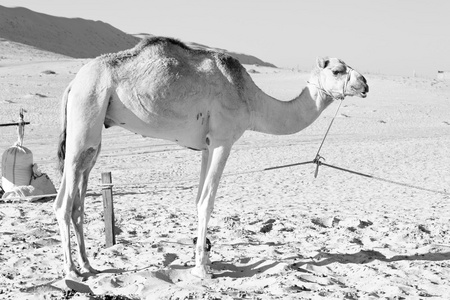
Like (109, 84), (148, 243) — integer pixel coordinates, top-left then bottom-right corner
(0, 0), (450, 78)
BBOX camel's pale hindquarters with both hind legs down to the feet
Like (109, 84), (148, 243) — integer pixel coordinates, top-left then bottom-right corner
(54, 61), (111, 279)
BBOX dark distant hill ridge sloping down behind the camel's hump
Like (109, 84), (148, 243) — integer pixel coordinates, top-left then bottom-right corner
(0, 5), (275, 67)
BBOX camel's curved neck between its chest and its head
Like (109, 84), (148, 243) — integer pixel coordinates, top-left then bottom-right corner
(250, 77), (333, 135)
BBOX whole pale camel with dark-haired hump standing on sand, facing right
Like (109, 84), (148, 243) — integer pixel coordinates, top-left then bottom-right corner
(54, 37), (369, 280)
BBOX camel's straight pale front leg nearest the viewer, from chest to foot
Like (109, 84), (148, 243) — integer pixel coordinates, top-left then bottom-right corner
(191, 146), (231, 278)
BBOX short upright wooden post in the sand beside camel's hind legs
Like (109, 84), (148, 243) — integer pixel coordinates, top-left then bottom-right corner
(102, 172), (116, 248)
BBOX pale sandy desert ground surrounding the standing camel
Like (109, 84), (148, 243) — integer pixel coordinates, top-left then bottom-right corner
(0, 43), (450, 299)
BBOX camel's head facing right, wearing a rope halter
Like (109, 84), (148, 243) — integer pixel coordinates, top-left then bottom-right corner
(317, 58), (369, 99)
